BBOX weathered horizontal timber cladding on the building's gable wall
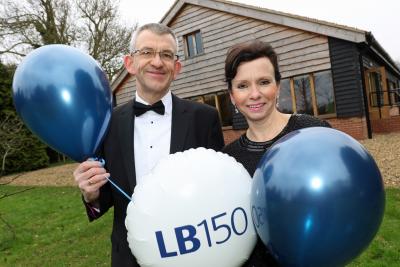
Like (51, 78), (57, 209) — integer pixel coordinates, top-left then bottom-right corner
(116, 4), (331, 105)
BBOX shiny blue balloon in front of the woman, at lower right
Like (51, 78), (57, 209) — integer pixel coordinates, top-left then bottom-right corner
(251, 127), (385, 266)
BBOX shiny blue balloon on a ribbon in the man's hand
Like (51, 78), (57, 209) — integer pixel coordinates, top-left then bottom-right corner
(13, 45), (112, 161)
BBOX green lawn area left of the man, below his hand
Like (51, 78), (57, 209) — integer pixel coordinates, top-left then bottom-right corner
(0, 186), (112, 266)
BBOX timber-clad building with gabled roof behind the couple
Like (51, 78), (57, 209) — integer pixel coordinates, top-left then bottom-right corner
(112, 0), (400, 142)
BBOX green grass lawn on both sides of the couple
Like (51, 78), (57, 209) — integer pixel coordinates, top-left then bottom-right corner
(0, 186), (400, 267)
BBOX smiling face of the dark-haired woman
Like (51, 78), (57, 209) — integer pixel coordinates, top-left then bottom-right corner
(230, 57), (279, 121)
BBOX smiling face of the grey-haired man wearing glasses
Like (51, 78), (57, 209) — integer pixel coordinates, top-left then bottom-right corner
(125, 30), (181, 101)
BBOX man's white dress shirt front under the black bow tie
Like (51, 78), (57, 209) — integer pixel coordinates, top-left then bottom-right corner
(133, 91), (172, 184)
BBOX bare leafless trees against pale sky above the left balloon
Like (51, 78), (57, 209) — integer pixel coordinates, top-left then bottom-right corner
(0, 0), (133, 79)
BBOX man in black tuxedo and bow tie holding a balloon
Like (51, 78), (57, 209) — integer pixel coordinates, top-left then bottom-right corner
(74, 23), (224, 267)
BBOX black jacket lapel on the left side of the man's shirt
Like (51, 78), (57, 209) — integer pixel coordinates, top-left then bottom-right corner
(118, 99), (136, 192)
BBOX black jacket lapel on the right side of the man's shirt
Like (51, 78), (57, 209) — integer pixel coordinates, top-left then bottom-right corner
(170, 95), (190, 154)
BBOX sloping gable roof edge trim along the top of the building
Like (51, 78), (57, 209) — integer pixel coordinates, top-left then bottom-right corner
(111, 0), (398, 91)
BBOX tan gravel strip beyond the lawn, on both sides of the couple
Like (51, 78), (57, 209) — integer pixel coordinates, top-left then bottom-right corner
(0, 133), (400, 187)
